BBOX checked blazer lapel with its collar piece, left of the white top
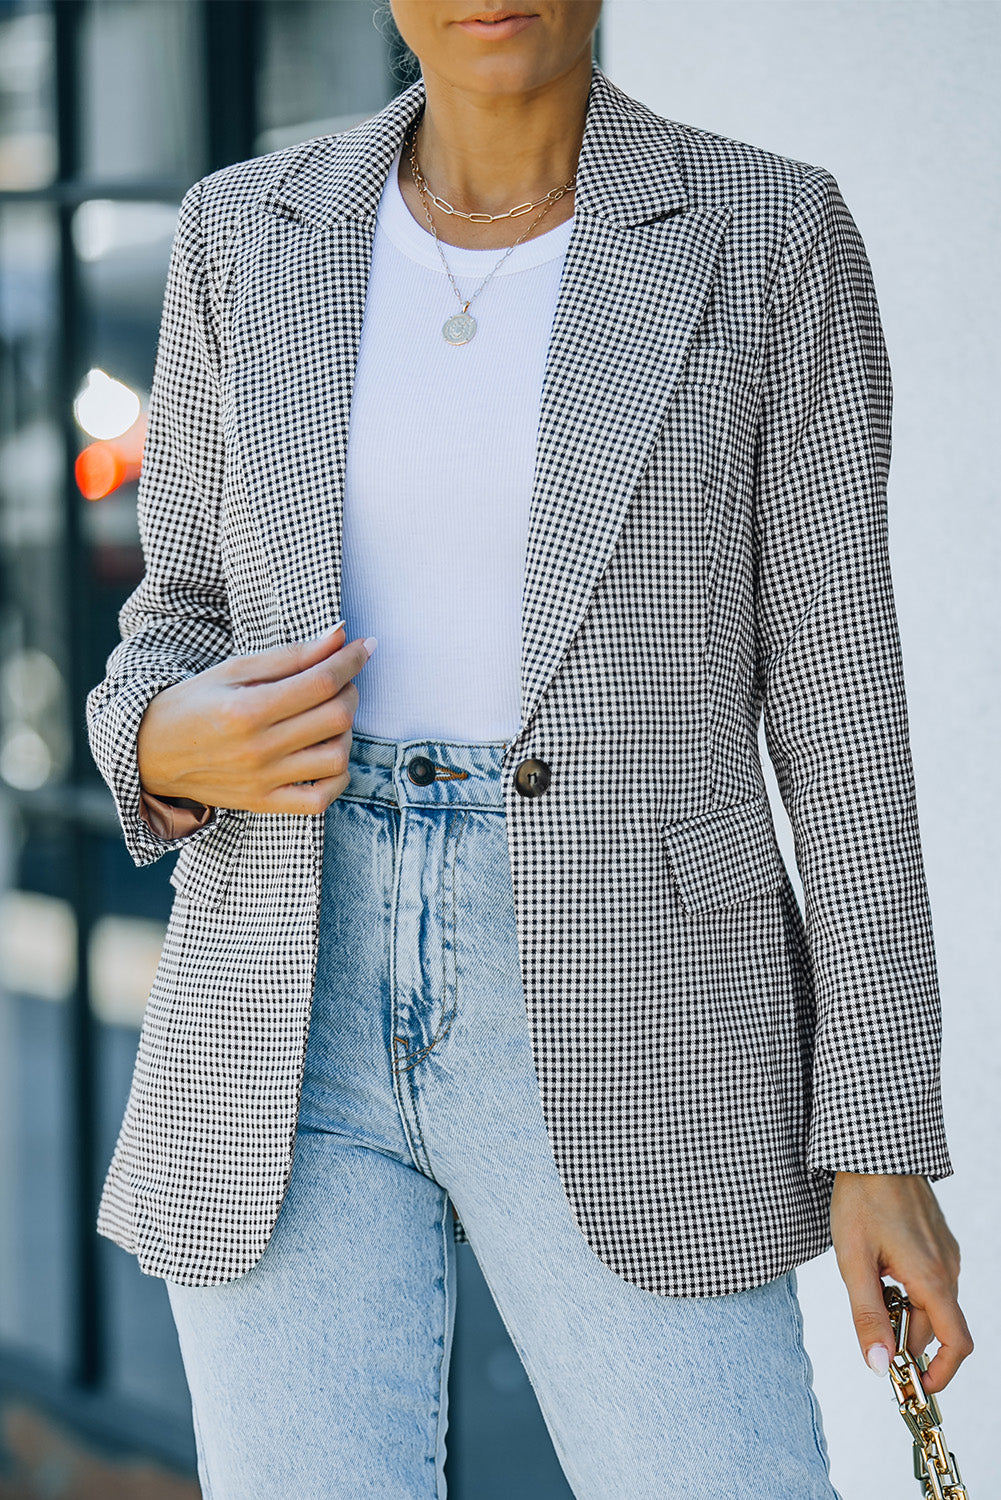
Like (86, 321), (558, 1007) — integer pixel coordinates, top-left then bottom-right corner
(246, 84), (423, 641)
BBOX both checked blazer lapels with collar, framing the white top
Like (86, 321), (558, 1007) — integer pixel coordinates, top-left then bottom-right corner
(252, 66), (729, 687)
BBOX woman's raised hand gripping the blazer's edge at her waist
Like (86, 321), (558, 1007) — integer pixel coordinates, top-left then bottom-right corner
(137, 626), (375, 813)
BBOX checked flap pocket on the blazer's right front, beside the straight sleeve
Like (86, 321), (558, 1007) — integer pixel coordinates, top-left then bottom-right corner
(660, 797), (785, 912)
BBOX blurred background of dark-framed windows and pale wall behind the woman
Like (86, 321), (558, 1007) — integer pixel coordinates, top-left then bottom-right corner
(0, 0), (1001, 1500)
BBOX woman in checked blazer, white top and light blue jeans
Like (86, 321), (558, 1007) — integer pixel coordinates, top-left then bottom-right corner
(89, 0), (972, 1500)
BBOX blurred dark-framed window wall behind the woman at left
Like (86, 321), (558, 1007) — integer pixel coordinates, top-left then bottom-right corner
(0, 0), (588, 1500)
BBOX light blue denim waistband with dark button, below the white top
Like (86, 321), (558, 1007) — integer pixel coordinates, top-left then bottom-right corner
(341, 734), (507, 812)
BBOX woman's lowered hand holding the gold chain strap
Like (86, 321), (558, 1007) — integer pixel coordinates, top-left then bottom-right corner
(831, 1172), (972, 1394)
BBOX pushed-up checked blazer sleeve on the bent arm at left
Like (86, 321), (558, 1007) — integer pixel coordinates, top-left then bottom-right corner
(87, 183), (233, 864)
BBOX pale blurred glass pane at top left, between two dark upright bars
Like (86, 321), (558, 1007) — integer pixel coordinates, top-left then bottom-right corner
(80, 0), (203, 182)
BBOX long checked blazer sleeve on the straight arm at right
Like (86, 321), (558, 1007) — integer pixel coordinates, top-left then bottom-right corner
(755, 171), (951, 1179)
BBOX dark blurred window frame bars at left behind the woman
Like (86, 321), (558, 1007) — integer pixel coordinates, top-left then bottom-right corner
(0, 0), (399, 1473)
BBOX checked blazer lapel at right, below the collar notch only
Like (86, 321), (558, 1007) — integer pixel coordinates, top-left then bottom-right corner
(521, 207), (731, 728)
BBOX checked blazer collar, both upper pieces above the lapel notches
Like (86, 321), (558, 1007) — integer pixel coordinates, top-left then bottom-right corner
(267, 63), (687, 227)
